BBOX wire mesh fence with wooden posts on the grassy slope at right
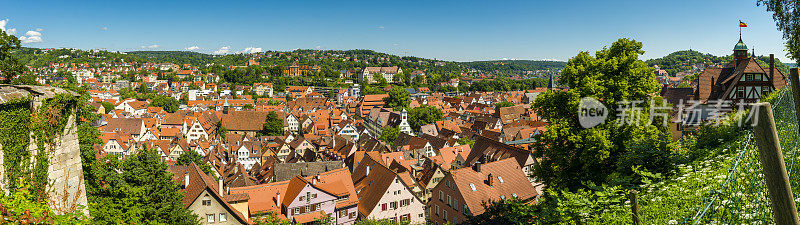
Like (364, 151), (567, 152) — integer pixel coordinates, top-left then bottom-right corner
(683, 86), (800, 224)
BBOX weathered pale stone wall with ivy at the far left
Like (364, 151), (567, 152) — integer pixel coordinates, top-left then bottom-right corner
(0, 85), (88, 215)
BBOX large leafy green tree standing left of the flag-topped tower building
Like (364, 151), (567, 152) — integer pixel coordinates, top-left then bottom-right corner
(532, 38), (674, 190)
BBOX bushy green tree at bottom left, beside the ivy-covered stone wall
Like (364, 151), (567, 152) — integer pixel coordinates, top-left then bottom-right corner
(89, 147), (199, 224)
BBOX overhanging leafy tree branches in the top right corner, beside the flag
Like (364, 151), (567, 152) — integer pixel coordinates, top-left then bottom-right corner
(756, 0), (800, 63)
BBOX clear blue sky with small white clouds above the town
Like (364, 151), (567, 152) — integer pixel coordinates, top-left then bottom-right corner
(0, 0), (786, 61)
